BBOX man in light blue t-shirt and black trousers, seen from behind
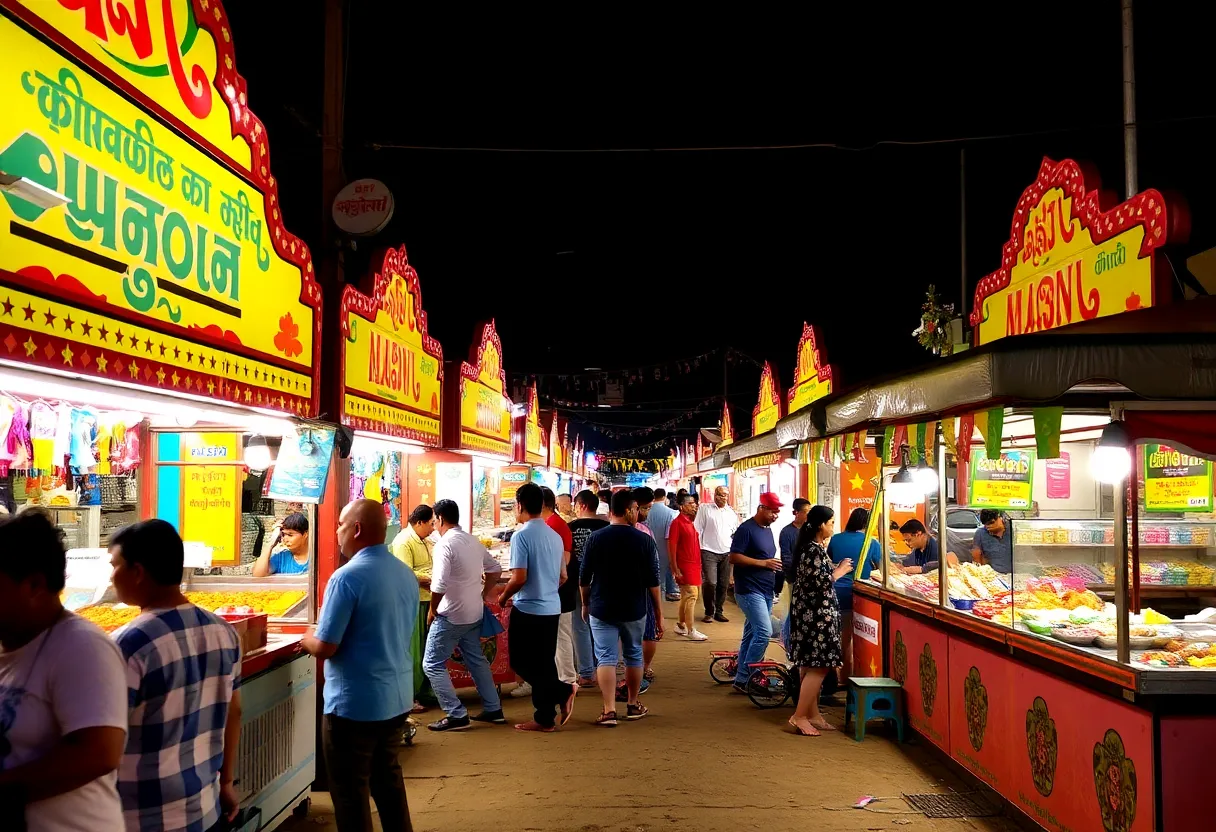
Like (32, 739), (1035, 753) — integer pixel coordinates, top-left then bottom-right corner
(499, 483), (579, 733)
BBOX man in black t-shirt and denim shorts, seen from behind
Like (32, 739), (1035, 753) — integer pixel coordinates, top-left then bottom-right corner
(579, 489), (663, 727)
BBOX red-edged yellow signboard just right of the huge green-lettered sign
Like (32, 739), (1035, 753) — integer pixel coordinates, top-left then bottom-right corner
(342, 246), (444, 445)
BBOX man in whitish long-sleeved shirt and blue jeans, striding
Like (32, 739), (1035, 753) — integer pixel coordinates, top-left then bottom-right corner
(422, 500), (507, 731)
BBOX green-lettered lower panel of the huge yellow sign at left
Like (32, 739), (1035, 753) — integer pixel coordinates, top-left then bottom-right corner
(0, 11), (321, 415)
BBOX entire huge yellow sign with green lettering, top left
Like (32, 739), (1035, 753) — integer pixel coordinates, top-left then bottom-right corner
(0, 0), (321, 415)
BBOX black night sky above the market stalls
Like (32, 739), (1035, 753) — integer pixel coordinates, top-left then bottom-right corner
(226, 0), (1216, 445)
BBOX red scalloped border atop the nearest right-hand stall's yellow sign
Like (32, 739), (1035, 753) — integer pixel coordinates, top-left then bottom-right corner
(969, 156), (1190, 328)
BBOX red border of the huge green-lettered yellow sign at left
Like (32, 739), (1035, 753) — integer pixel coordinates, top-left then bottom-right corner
(0, 0), (321, 416)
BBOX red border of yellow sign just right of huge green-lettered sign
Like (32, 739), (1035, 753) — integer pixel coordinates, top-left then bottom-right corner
(339, 246), (444, 445)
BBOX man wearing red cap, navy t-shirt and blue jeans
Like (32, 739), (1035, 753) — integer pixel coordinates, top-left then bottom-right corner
(731, 491), (782, 693)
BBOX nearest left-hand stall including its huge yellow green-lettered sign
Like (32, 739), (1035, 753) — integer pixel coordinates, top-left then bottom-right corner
(0, 0), (333, 828)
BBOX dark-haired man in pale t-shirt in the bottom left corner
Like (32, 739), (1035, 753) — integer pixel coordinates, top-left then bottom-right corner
(0, 511), (128, 832)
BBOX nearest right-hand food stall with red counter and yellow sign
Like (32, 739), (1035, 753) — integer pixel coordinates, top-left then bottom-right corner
(797, 161), (1216, 831)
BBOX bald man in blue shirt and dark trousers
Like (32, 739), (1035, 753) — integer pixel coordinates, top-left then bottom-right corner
(302, 500), (418, 832)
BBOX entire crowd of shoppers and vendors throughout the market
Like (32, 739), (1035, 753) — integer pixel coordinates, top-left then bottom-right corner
(0, 471), (1009, 832)
